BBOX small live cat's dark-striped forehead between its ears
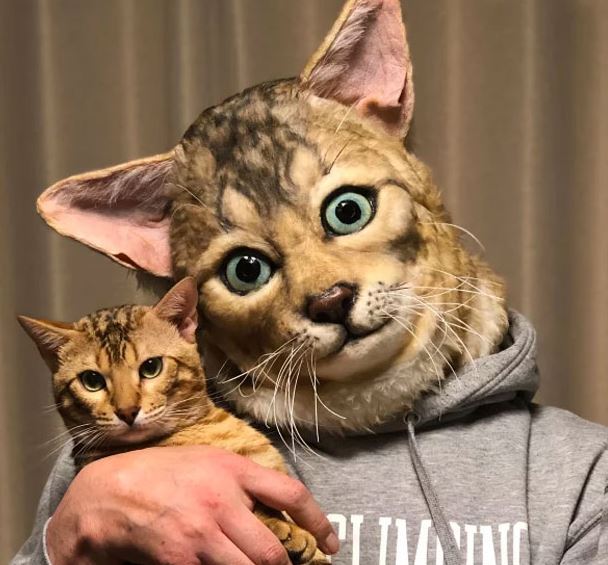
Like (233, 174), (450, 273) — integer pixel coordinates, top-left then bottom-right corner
(76, 305), (146, 363)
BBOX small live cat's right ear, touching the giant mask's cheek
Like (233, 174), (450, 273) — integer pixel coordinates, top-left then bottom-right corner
(153, 277), (198, 343)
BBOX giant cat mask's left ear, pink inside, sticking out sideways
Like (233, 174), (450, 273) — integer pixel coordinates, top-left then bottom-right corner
(37, 151), (174, 277)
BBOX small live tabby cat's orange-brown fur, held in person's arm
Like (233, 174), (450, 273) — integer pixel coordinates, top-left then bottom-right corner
(19, 278), (326, 564)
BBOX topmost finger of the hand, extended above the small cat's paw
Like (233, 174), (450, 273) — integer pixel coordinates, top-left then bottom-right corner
(243, 468), (340, 554)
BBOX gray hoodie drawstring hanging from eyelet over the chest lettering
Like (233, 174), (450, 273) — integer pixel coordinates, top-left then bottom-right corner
(406, 413), (463, 565)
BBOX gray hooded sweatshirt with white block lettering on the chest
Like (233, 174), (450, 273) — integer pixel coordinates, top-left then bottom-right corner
(11, 312), (608, 565)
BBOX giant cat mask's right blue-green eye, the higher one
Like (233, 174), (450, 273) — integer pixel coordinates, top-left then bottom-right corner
(321, 186), (376, 235)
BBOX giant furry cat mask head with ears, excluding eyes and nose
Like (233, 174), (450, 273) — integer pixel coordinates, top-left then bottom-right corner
(33, 0), (508, 433)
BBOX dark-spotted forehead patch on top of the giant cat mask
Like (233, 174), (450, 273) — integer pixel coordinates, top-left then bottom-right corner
(177, 81), (314, 220)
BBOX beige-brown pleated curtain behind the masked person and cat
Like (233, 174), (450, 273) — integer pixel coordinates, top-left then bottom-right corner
(0, 0), (608, 563)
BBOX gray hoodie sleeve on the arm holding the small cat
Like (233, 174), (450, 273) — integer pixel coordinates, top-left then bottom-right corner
(10, 445), (75, 565)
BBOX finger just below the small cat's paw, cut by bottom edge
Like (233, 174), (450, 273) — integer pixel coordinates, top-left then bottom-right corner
(220, 510), (291, 565)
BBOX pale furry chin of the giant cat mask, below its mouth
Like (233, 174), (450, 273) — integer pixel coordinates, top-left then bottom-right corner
(317, 320), (409, 382)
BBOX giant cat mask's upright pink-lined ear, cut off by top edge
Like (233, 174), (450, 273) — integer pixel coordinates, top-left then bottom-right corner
(300, 0), (414, 137)
